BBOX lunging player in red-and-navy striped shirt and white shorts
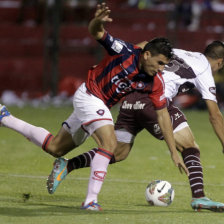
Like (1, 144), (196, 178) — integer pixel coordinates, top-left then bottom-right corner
(0, 3), (188, 211)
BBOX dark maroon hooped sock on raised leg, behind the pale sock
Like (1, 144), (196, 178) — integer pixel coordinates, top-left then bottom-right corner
(67, 148), (116, 173)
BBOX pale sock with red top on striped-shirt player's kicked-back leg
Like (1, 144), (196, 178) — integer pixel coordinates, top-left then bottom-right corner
(1, 115), (53, 150)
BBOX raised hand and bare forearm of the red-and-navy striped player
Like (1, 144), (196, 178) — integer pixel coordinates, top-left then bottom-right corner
(88, 3), (112, 40)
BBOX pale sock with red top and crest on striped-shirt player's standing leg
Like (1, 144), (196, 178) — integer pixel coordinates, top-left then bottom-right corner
(84, 148), (113, 206)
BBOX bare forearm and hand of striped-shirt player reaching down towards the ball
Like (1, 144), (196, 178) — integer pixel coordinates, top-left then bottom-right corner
(156, 108), (189, 175)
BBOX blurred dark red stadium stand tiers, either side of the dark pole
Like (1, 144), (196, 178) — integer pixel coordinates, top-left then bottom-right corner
(0, 0), (224, 102)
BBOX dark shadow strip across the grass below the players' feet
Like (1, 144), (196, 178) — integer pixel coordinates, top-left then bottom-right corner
(0, 203), (206, 217)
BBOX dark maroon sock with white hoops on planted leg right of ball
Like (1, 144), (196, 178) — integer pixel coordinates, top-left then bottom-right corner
(182, 148), (205, 198)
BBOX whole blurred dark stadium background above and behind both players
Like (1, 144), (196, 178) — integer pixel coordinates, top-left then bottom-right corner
(0, 0), (224, 108)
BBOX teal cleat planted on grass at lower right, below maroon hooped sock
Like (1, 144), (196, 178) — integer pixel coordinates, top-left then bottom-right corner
(191, 197), (224, 212)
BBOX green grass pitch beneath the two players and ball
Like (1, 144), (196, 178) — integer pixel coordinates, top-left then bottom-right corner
(0, 107), (224, 224)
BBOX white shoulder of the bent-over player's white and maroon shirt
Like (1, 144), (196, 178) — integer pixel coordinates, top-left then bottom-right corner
(173, 49), (209, 74)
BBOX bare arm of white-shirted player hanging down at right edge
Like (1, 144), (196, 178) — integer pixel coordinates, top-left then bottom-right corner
(205, 100), (224, 153)
